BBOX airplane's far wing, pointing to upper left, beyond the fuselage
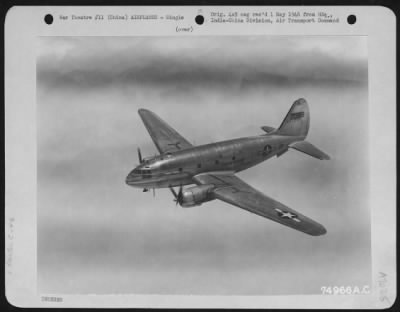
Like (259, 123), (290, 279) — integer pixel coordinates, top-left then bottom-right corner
(138, 109), (193, 154)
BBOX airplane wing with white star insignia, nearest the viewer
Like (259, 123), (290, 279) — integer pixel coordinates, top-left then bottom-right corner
(193, 173), (326, 236)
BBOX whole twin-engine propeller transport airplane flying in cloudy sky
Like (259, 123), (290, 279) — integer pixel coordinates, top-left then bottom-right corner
(126, 99), (329, 236)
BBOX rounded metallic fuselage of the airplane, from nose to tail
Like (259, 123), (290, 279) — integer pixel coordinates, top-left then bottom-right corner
(126, 134), (303, 188)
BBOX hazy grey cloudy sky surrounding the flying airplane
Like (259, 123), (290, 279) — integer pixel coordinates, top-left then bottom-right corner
(37, 36), (371, 295)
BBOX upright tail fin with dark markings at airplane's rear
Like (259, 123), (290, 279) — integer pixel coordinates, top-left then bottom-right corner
(276, 99), (310, 138)
